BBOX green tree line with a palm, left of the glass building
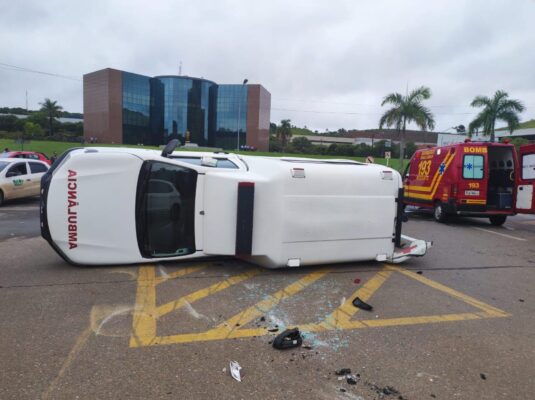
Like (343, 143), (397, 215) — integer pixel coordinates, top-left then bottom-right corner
(0, 98), (84, 141)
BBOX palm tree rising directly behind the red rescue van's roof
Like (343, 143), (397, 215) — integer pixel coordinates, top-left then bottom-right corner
(468, 90), (525, 142)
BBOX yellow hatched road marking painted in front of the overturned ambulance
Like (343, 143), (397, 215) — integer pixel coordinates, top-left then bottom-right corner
(130, 265), (510, 347)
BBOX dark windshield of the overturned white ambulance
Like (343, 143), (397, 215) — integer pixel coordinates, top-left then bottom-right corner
(136, 161), (197, 257)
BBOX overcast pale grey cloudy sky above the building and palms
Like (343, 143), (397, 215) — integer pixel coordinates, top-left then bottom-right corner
(0, 0), (535, 130)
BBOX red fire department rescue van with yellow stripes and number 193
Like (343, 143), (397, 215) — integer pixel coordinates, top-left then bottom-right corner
(404, 139), (535, 225)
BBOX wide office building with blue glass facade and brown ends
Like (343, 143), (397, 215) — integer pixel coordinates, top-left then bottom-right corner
(84, 69), (271, 150)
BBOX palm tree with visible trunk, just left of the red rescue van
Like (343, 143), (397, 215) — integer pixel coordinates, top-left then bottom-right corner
(379, 86), (435, 172)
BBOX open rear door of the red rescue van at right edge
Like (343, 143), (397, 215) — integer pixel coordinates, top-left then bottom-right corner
(515, 144), (535, 214)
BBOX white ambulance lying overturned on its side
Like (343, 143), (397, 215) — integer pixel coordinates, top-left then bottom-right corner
(41, 144), (430, 268)
